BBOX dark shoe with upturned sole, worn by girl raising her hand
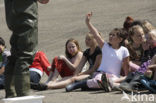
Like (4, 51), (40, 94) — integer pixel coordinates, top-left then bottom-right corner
(97, 74), (112, 92)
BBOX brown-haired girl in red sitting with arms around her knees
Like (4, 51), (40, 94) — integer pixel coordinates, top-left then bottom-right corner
(32, 38), (83, 90)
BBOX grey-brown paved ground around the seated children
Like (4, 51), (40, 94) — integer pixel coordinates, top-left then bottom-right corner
(0, 0), (156, 103)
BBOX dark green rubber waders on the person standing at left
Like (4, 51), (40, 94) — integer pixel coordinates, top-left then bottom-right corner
(5, 0), (38, 98)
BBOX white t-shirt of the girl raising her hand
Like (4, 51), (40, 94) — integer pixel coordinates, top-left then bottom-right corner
(98, 42), (129, 77)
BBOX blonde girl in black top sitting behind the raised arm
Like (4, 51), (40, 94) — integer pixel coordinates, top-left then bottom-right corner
(75, 33), (102, 76)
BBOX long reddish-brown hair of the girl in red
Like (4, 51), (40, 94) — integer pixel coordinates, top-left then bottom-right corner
(65, 38), (81, 59)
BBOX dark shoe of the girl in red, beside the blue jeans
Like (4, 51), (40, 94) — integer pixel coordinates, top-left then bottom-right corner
(30, 82), (48, 91)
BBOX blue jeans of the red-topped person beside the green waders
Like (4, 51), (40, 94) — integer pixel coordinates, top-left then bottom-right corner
(30, 71), (41, 83)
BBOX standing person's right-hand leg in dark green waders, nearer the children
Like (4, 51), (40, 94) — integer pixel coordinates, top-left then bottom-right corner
(13, 0), (38, 96)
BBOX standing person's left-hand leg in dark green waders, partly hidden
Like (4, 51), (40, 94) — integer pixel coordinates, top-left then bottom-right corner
(4, 0), (16, 98)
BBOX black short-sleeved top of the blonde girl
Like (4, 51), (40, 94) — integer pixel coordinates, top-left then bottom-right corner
(83, 46), (102, 69)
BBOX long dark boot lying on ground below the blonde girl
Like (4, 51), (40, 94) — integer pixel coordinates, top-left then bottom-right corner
(66, 80), (88, 92)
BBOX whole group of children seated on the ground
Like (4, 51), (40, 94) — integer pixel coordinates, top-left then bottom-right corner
(0, 12), (156, 93)
